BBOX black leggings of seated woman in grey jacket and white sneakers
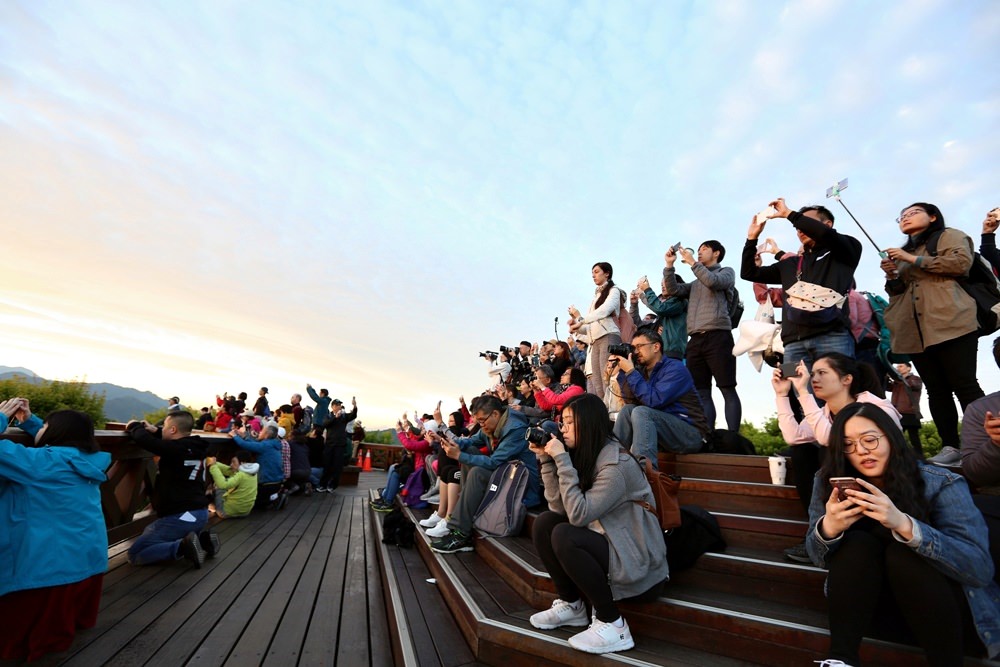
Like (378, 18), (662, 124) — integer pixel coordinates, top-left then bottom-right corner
(531, 512), (663, 623)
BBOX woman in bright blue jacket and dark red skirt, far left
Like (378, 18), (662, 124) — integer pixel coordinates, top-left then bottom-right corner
(0, 398), (111, 662)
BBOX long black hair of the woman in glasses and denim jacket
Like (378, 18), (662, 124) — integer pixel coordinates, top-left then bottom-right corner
(819, 403), (930, 521)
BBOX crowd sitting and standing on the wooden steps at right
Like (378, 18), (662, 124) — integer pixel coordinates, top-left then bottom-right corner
(384, 199), (1000, 665)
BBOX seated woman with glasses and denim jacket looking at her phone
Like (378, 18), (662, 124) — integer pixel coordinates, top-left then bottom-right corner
(808, 403), (1000, 666)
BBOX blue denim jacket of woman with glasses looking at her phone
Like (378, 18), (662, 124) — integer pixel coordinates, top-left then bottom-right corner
(806, 463), (1000, 658)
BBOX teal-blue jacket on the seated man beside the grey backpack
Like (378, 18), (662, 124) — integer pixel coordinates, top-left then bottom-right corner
(455, 410), (542, 507)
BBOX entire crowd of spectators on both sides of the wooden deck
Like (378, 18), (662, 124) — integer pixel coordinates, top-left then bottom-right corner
(0, 198), (1000, 665)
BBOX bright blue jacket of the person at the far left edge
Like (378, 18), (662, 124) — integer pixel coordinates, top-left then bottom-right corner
(0, 414), (111, 596)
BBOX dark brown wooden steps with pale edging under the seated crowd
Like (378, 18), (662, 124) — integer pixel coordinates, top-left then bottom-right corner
(375, 454), (1000, 667)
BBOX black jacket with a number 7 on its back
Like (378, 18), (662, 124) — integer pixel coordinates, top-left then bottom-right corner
(128, 423), (208, 516)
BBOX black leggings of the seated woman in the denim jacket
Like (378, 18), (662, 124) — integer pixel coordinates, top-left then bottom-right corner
(827, 518), (983, 667)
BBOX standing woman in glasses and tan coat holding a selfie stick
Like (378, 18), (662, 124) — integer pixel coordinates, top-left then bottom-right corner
(882, 203), (983, 463)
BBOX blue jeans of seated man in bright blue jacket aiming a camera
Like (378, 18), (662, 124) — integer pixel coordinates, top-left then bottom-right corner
(612, 405), (702, 470)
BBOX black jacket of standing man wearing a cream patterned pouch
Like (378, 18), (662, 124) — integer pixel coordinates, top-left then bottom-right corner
(740, 211), (861, 343)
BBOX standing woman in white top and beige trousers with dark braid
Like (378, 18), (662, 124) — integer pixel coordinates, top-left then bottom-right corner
(569, 262), (625, 397)
